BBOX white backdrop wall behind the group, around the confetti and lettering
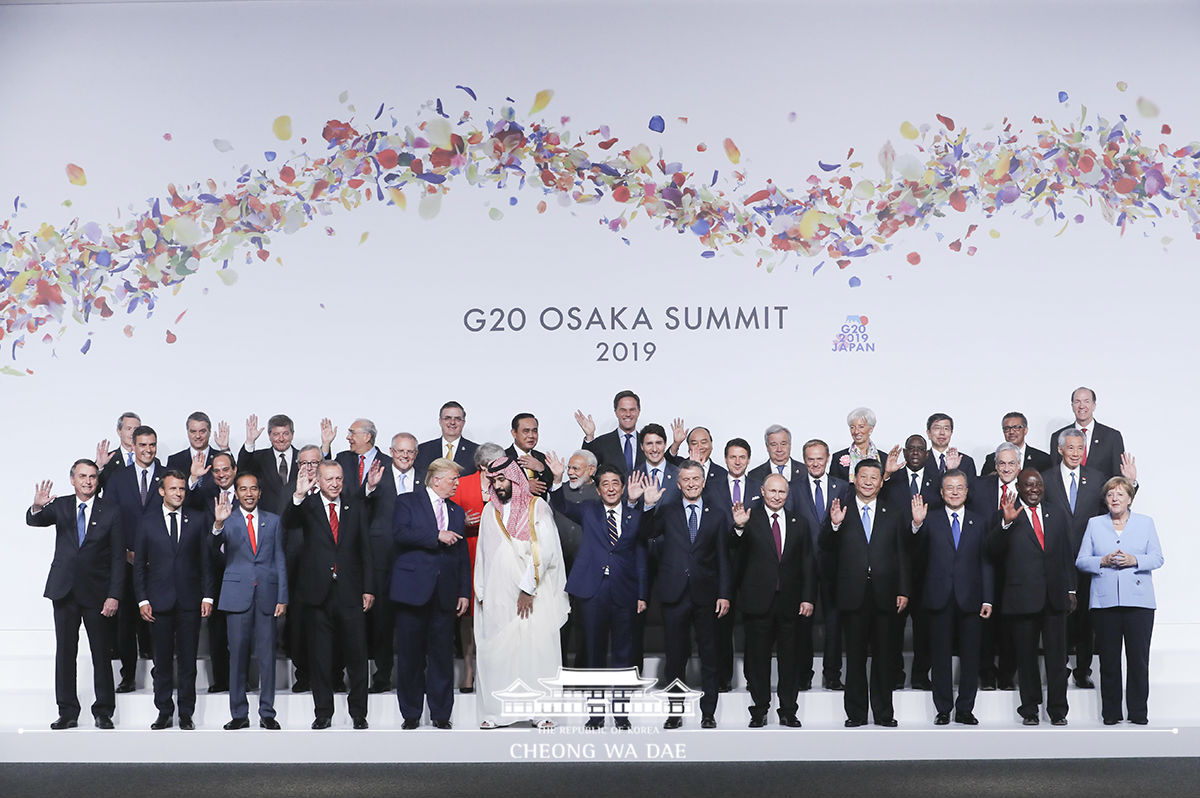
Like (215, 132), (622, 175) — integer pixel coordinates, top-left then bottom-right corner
(0, 0), (1200, 629)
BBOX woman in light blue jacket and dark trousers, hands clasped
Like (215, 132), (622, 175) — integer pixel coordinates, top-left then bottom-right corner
(1075, 476), (1163, 726)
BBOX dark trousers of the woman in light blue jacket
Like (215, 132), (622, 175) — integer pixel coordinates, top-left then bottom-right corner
(1092, 607), (1154, 721)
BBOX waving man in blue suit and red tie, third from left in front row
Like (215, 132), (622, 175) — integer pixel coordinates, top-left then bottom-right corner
(212, 474), (288, 731)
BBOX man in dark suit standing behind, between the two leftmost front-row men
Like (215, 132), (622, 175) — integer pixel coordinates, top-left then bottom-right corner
(104, 425), (167, 692)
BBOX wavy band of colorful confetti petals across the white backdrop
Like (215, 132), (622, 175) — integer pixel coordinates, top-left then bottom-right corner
(0, 86), (1200, 374)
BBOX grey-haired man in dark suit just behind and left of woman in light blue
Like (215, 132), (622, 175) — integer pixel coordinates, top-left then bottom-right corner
(1042, 427), (1104, 689)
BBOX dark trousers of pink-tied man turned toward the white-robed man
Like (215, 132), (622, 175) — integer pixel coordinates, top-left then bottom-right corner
(395, 593), (457, 720)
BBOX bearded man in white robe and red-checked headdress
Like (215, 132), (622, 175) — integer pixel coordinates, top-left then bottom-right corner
(475, 456), (570, 728)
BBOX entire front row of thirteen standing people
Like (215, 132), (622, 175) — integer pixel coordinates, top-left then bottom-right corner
(26, 444), (1163, 730)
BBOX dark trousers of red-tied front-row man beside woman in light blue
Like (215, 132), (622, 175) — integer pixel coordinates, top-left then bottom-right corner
(1009, 607), (1067, 720)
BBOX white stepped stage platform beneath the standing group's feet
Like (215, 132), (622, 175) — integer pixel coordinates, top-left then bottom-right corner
(0, 625), (1200, 763)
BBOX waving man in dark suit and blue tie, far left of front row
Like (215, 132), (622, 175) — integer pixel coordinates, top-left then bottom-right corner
(25, 460), (125, 731)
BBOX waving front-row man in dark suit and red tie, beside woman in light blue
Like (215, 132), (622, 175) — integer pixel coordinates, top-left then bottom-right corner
(986, 468), (1075, 726)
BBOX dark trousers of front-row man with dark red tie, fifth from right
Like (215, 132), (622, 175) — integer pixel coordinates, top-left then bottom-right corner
(742, 593), (812, 718)
